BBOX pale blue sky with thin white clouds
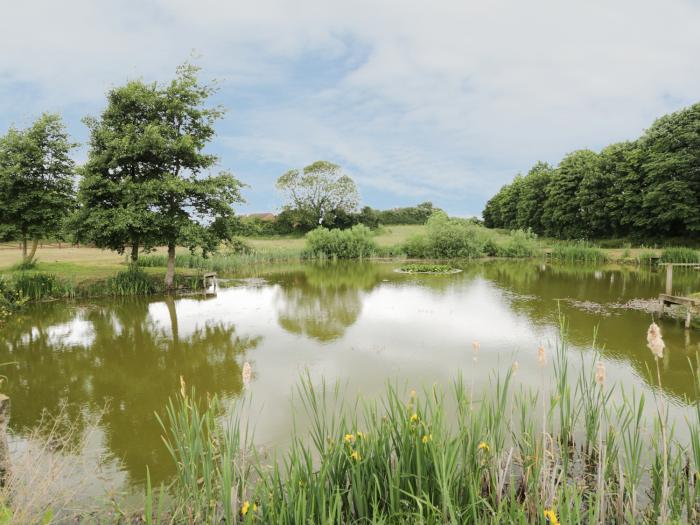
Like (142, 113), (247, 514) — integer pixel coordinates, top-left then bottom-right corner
(0, 0), (700, 216)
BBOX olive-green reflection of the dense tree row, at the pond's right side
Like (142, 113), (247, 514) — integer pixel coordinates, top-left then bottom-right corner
(484, 262), (700, 399)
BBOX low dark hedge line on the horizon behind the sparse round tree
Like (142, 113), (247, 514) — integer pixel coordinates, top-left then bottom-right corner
(237, 202), (439, 237)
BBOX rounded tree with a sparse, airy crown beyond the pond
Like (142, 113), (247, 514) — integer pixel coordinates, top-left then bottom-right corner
(277, 160), (359, 227)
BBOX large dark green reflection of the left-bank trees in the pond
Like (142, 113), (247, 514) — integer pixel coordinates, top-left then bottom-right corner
(0, 299), (260, 479)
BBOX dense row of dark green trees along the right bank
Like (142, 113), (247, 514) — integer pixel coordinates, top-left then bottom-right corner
(483, 104), (700, 240)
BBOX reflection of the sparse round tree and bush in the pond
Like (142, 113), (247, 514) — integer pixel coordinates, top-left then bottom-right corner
(277, 262), (381, 342)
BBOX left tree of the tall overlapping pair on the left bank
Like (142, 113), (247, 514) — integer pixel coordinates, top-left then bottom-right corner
(72, 80), (161, 262)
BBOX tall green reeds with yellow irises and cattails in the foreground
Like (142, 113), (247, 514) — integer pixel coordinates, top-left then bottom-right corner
(139, 322), (700, 524)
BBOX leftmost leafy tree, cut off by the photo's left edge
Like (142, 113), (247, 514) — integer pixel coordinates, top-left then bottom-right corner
(0, 113), (76, 264)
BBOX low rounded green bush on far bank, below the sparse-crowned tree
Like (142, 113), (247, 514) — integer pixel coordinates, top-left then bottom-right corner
(306, 225), (377, 259)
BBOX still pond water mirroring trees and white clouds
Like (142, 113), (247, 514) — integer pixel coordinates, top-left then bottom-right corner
(0, 261), (700, 486)
